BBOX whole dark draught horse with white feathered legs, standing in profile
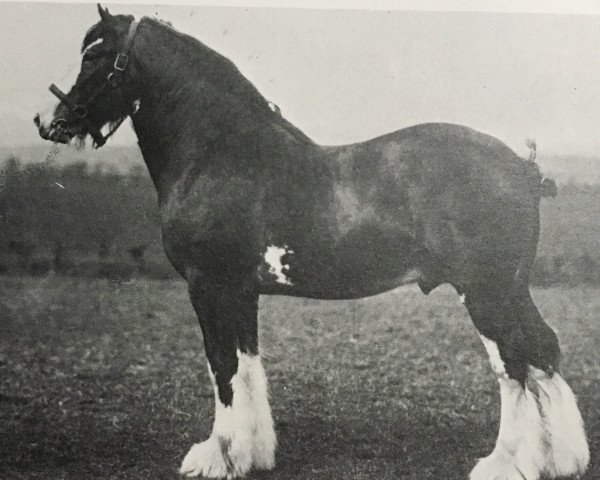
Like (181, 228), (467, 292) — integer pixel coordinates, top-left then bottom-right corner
(35, 7), (589, 480)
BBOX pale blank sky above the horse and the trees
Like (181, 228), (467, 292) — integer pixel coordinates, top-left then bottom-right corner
(0, 1), (600, 156)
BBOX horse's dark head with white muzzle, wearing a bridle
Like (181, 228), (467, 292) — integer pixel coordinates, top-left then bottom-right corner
(34, 5), (137, 147)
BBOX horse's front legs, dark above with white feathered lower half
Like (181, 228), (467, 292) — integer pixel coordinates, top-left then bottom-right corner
(180, 276), (275, 478)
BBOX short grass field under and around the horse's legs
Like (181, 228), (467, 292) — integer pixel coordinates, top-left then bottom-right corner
(0, 277), (600, 480)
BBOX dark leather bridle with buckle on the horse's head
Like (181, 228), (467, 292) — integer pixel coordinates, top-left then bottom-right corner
(50, 20), (139, 148)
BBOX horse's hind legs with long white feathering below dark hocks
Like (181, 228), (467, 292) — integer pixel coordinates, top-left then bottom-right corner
(464, 285), (589, 480)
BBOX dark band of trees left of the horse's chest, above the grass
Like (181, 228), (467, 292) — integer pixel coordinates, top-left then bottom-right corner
(0, 156), (173, 276)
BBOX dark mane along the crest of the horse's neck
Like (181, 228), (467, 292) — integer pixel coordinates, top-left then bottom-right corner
(144, 17), (313, 143)
